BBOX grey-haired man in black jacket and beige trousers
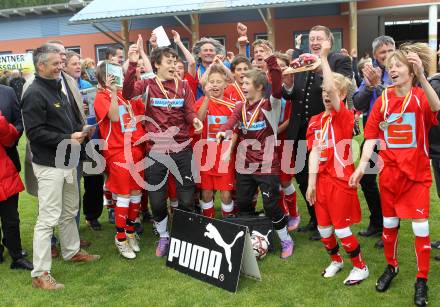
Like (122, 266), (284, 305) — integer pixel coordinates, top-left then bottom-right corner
(22, 44), (99, 290)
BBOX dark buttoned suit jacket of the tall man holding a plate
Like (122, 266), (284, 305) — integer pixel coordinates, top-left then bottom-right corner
(283, 53), (353, 141)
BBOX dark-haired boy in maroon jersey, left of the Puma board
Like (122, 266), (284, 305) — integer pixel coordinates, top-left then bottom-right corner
(122, 45), (203, 257)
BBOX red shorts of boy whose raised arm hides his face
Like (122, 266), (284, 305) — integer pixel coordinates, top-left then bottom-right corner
(315, 174), (362, 229)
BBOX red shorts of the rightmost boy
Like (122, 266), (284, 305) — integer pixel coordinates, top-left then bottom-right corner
(379, 165), (430, 219)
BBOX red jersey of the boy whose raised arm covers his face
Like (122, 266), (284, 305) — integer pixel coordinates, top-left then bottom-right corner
(307, 101), (354, 189)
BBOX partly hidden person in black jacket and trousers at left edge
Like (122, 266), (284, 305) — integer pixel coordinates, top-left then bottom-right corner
(0, 85), (33, 270)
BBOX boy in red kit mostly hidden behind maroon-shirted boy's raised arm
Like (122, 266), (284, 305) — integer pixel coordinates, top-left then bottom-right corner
(275, 52), (301, 231)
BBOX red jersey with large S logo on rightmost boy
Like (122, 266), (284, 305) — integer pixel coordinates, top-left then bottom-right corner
(364, 87), (438, 185)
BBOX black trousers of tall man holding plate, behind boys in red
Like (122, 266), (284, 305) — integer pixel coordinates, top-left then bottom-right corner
(294, 125), (318, 225)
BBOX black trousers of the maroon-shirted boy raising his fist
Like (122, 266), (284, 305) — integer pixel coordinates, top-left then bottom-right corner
(236, 174), (287, 230)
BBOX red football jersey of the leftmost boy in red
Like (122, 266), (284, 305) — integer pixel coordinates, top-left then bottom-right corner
(94, 90), (145, 154)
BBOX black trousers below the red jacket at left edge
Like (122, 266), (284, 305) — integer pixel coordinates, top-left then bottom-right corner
(0, 194), (23, 261)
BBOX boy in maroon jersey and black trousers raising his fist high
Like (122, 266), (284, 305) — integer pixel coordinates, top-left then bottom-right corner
(217, 45), (294, 259)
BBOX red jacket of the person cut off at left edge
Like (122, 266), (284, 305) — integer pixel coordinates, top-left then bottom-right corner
(0, 114), (24, 201)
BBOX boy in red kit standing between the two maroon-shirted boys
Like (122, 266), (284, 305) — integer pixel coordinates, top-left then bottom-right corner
(195, 65), (235, 218)
